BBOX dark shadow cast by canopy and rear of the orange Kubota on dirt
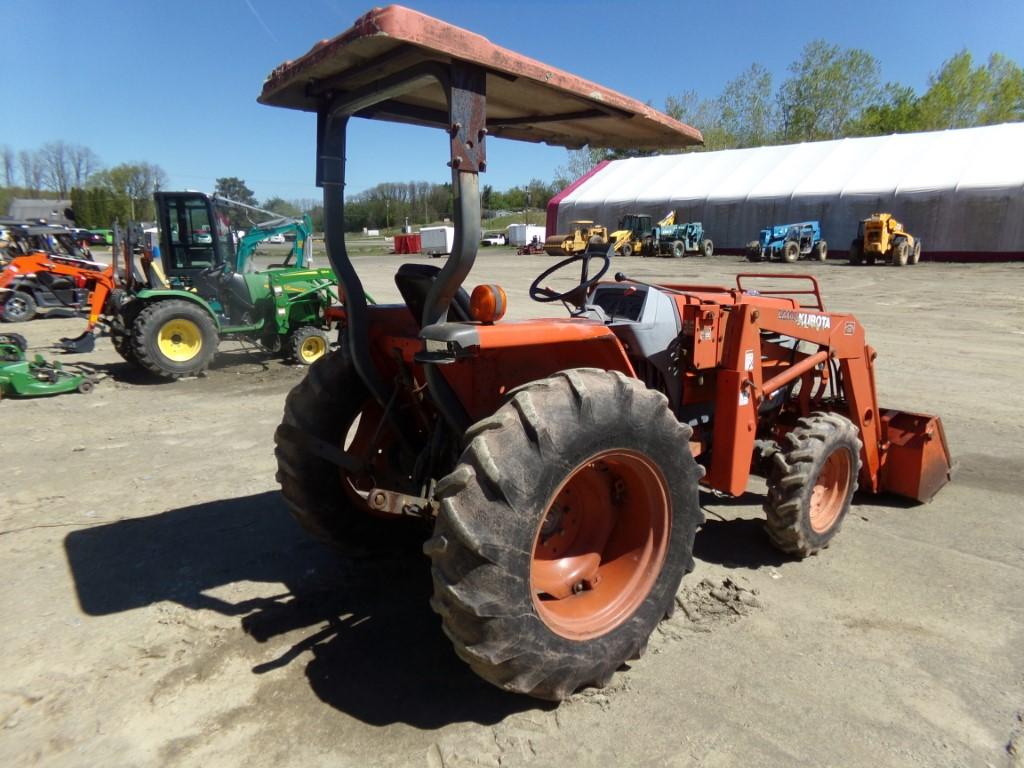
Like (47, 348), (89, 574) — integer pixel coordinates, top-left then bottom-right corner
(65, 493), (553, 729)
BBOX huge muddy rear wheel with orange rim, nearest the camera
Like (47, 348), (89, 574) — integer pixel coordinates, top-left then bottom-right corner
(423, 369), (703, 700)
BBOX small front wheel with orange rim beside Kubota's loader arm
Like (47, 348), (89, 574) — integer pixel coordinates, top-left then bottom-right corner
(764, 413), (861, 557)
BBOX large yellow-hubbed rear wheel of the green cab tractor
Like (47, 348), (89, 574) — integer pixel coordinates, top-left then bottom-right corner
(131, 299), (218, 380)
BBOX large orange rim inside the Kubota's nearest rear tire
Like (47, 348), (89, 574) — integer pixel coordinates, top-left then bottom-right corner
(529, 451), (672, 640)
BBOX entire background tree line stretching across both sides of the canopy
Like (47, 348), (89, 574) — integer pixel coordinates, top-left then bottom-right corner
(8, 40), (1024, 230)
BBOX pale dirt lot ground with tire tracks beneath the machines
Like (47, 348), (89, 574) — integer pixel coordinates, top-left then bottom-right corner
(0, 249), (1024, 768)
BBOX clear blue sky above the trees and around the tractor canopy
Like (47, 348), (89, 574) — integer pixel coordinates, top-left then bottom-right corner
(0, 0), (1024, 200)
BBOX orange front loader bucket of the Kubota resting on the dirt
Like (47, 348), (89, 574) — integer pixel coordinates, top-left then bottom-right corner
(879, 411), (952, 502)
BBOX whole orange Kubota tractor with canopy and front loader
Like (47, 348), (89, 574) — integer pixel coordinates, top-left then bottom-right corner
(259, 6), (950, 699)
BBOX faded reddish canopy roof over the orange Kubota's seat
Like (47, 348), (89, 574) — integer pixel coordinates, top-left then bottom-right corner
(258, 5), (702, 148)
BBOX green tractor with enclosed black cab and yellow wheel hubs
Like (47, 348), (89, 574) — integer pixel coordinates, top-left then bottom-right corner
(111, 191), (337, 379)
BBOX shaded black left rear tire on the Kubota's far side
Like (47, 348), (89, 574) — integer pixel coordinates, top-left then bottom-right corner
(273, 347), (426, 556)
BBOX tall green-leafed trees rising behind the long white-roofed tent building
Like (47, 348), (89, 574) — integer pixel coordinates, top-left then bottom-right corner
(556, 47), (1024, 182)
